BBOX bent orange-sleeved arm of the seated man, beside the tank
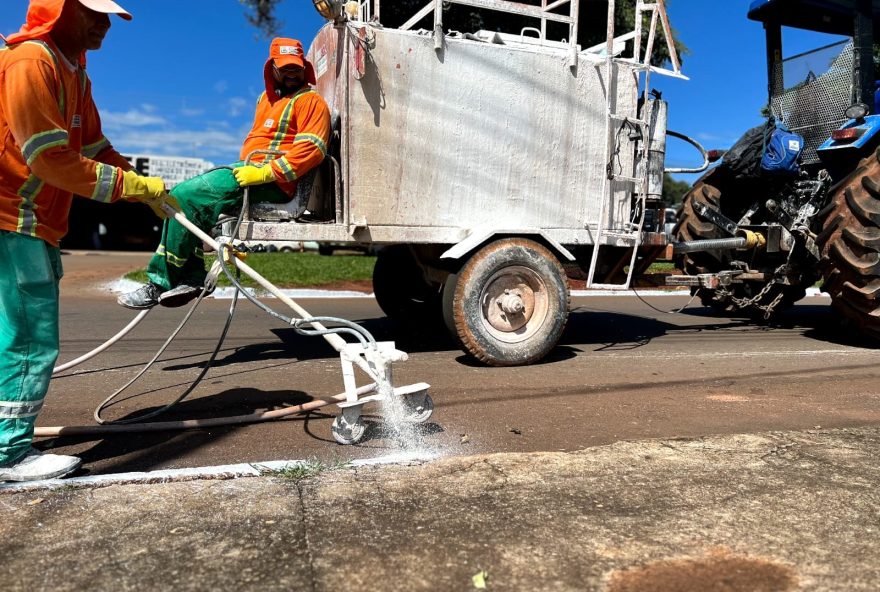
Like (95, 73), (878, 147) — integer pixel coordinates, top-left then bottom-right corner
(272, 92), (330, 181)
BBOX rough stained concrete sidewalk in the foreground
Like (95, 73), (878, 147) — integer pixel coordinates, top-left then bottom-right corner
(0, 427), (880, 592)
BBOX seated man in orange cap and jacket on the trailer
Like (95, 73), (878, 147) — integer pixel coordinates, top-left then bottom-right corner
(118, 38), (330, 309)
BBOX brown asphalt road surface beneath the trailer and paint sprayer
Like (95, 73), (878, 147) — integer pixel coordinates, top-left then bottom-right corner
(44, 251), (880, 474)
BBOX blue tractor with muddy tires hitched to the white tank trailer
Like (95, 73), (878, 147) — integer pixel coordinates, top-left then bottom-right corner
(669, 0), (880, 338)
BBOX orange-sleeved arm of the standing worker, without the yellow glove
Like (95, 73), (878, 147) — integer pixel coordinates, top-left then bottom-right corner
(0, 60), (123, 202)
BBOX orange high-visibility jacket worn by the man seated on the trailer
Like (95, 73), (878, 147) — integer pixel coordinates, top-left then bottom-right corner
(240, 86), (330, 195)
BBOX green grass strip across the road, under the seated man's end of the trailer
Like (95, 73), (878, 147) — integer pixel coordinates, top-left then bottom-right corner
(125, 253), (376, 288)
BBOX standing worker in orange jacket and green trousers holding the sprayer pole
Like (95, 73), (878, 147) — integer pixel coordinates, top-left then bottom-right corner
(0, 0), (179, 481)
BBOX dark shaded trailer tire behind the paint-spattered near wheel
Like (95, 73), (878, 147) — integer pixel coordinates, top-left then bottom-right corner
(373, 245), (440, 321)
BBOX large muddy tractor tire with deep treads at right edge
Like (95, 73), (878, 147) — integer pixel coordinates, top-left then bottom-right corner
(816, 150), (880, 339)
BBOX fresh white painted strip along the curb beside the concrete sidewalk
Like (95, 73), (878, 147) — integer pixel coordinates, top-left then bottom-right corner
(0, 451), (438, 494)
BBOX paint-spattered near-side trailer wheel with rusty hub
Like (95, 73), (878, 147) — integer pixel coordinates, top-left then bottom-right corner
(444, 238), (569, 366)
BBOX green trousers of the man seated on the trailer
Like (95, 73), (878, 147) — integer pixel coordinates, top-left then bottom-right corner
(147, 162), (290, 290)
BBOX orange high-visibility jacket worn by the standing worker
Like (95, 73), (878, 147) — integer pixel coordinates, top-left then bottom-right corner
(0, 35), (131, 246)
